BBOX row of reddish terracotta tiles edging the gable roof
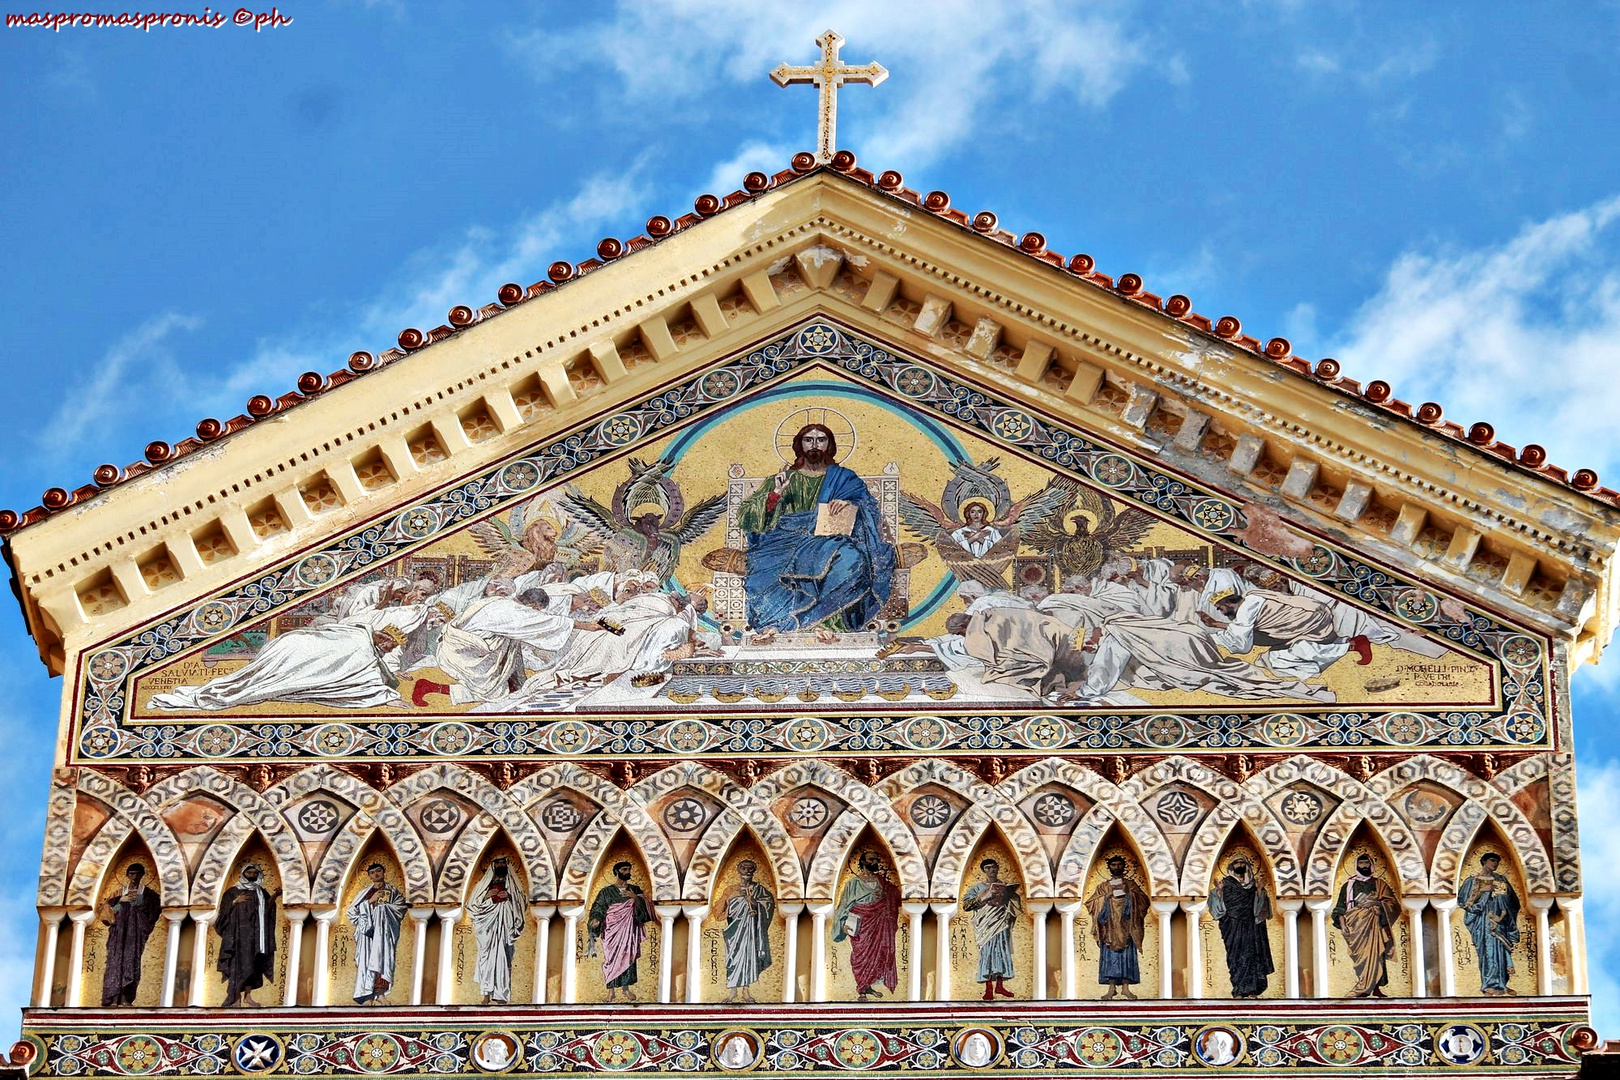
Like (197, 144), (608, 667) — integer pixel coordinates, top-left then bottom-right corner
(0, 151), (1620, 534)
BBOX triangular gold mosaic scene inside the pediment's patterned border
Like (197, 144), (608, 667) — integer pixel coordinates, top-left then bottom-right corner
(134, 365), (1494, 719)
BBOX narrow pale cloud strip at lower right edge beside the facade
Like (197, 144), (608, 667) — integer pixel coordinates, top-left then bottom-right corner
(1576, 761), (1620, 1038)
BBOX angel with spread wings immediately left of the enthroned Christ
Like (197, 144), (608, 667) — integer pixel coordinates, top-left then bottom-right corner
(562, 458), (726, 581)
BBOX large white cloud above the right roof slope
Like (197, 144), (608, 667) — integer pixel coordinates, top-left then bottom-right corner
(1332, 196), (1620, 481)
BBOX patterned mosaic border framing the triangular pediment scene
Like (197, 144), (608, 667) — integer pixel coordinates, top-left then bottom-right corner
(70, 319), (1557, 764)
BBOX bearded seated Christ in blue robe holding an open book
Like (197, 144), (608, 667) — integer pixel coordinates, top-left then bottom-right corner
(737, 424), (894, 631)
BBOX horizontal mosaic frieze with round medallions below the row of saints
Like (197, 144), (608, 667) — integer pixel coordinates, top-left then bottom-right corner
(23, 1004), (1586, 1077)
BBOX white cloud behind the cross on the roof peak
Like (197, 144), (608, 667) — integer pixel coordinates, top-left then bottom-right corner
(512, 0), (1166, 168)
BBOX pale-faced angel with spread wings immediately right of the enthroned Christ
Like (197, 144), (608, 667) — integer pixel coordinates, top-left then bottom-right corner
(899, 458), (1079, 589)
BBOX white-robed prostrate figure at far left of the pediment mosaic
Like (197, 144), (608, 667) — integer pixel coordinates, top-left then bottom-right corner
(151, 604), (442, 711)
